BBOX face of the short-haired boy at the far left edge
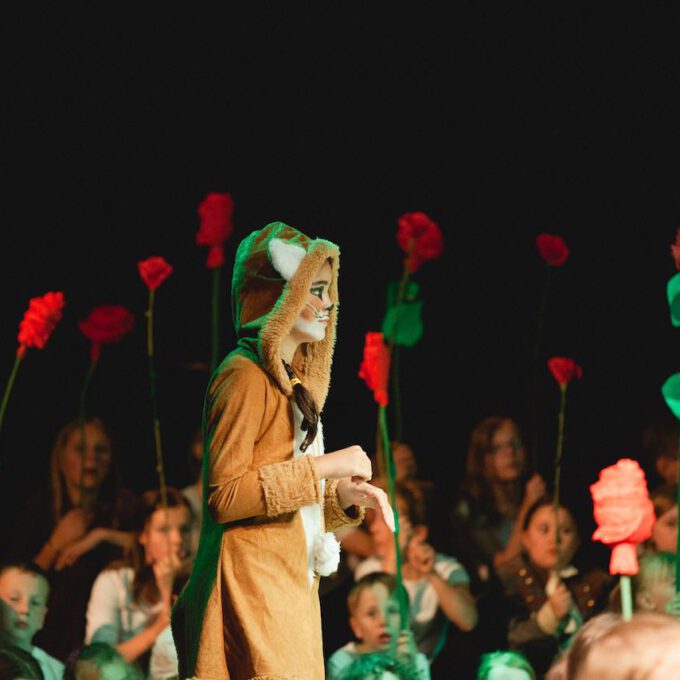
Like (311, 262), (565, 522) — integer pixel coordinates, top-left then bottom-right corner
(0, 567), (49, 651)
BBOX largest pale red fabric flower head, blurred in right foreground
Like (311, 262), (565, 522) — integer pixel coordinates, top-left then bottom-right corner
(590, 458), (655, 576)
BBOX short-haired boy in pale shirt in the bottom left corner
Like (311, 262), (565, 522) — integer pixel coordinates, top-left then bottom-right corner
(0, 562), (64, 680)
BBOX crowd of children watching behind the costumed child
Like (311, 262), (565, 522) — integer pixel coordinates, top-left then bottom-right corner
(0, 416), (680, 680)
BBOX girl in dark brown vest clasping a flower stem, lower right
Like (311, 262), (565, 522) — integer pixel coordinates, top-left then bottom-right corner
(498, 498), (611, 677)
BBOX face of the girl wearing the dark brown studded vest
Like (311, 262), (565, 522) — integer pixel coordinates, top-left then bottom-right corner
(522, 505), (578, 571)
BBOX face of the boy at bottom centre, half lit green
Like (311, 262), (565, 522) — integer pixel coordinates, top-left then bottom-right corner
(349, 583), (400, 653)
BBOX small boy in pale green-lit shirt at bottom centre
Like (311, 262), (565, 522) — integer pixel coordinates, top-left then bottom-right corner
(327, 572), (430, 680)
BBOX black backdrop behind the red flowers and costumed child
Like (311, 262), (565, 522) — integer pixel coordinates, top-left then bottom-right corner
(0, 1), (680, 568)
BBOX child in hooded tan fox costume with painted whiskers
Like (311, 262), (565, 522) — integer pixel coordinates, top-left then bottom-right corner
(172, 222), (392, 680)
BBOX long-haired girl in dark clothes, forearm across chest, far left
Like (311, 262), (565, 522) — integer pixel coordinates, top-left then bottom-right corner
(10, 418), (134, 661)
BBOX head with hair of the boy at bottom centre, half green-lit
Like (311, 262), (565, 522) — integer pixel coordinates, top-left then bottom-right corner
(347, 572), (400, 654)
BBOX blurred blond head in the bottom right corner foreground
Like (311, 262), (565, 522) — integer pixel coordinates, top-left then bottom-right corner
(570, 612), (680, 680)
